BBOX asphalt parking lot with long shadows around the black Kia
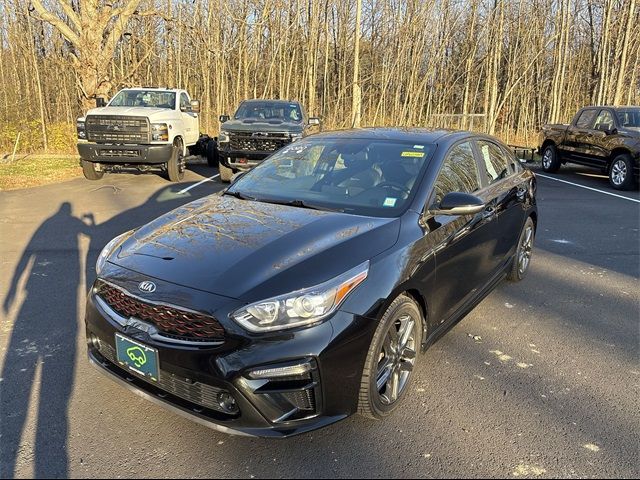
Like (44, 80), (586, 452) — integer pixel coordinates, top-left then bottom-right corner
(0, 166), (640, 478)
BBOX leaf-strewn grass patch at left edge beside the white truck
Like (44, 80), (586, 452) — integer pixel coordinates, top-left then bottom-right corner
(0, 155), (82, 190)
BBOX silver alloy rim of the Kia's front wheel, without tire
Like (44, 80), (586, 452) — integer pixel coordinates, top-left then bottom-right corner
(376, 314), (416, 405)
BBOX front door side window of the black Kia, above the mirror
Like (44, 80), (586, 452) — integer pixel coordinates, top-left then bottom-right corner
(435, 142), (480, 203)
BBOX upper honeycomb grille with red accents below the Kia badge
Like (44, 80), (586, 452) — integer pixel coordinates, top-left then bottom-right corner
(96, 280), (224, 342)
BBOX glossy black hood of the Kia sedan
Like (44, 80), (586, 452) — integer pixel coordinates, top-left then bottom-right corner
(109, 195), (400, 301)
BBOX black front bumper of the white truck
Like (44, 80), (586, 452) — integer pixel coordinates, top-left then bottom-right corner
(78, 142), (173, 165)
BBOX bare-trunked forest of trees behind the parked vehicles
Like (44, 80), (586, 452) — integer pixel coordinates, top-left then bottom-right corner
(0, 0), (640, 154)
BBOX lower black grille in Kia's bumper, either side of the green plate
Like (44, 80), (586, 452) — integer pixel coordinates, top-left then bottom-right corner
(98, 342), (235, 414)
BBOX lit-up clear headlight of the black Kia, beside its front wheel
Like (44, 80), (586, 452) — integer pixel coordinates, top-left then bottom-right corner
(231, 260), (369, 332)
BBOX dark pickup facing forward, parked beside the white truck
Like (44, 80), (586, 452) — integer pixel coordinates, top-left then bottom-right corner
(218, 100), (320, 182)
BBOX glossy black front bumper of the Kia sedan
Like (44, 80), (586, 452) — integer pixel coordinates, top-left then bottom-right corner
(86, 274), (375, 437)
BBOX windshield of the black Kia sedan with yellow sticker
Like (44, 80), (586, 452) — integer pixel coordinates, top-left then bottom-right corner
(228, 138), (433, 217)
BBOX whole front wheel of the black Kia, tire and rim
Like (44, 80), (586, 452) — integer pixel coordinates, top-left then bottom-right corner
(358, 295), (423, 419)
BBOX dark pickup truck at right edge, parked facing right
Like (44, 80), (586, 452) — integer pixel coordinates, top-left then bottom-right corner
(539, 106), (640, 190)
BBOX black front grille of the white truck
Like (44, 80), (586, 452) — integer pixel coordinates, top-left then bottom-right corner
(85, 115), (151, 143)
